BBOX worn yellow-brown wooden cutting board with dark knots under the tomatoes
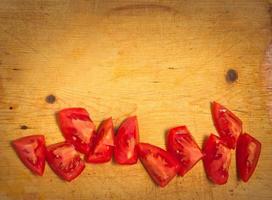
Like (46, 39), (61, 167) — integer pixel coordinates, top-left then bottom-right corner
(0, 0), (272, 200)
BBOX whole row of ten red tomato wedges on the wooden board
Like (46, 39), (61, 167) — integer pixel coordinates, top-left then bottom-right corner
(12, 102), (261, 187)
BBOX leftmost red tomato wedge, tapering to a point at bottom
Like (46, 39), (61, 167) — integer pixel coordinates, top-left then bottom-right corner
(12, 135), (45, 176)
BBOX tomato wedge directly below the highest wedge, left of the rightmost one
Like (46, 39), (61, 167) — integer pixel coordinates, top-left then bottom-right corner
(203, 134), (231, 185)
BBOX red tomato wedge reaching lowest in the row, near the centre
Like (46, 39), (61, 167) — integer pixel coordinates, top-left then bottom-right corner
(137, 143), (179, 187)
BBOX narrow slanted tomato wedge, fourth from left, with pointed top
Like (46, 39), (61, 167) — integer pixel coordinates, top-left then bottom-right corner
(86, 118), (114, 163)
